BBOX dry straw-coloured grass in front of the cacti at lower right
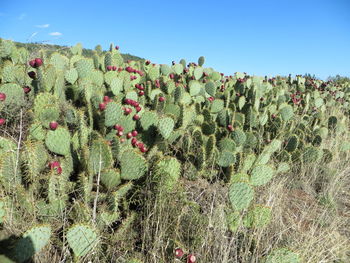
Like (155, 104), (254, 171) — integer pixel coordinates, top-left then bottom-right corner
(135, 111), (350, 263)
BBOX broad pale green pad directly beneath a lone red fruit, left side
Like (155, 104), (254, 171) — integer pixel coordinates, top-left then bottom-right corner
(45, 127), (71, 155)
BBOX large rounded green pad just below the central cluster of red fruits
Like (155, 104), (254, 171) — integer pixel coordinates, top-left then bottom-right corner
(120, 150), (148, 180)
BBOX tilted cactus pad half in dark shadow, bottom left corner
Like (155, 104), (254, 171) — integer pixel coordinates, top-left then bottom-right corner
(10, 225), (51, 262)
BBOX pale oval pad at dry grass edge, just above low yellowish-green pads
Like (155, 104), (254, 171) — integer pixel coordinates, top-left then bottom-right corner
(229, 182), (254, 211)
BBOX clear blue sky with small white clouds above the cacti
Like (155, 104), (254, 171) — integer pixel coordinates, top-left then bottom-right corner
(0, 0), (350, 78)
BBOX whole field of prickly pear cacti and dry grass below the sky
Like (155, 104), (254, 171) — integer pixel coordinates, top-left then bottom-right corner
(0, 40), (350, 263)
